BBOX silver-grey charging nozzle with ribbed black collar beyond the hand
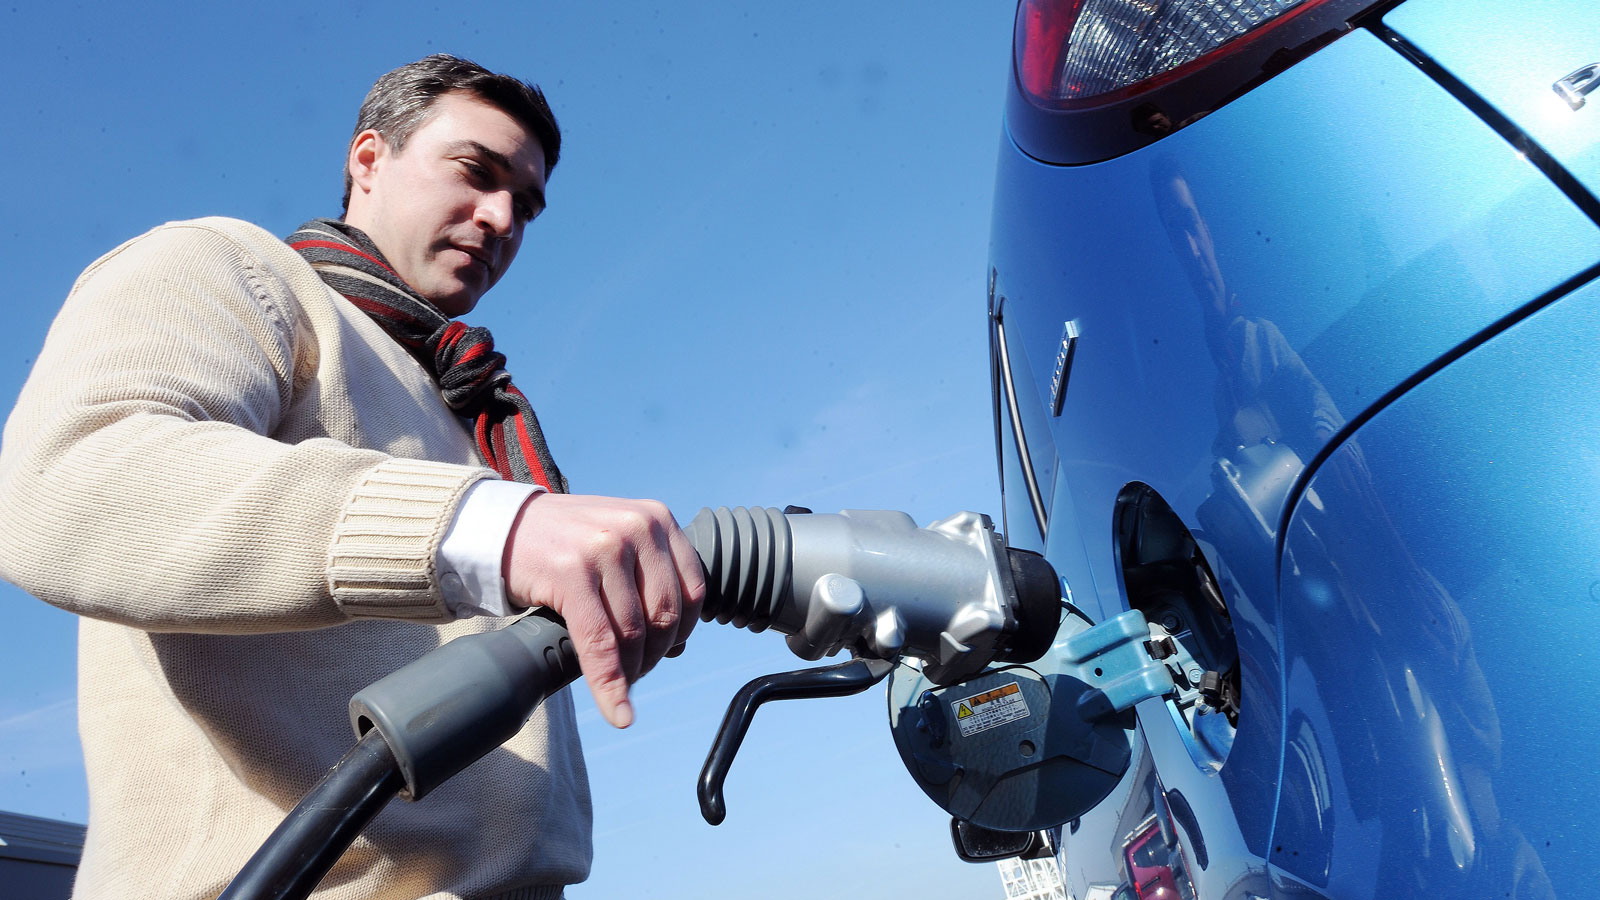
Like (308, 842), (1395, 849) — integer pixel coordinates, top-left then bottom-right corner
(683, 508), (1061, 684)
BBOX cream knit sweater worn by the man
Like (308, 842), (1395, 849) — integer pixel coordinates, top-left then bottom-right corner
(0, 219), (590, 900)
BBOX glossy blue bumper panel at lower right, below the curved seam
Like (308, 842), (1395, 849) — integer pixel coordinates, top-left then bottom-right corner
(1272, 275), (1600, 897)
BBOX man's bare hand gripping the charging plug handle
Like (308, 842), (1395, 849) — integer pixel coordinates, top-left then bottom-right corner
(502, 493), (706, 729)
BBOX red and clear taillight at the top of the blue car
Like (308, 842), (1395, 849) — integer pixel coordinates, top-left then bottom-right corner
(1014, 0), (1326, 109)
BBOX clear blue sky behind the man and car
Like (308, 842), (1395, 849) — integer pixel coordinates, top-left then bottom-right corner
(0, 0), (1013, 900)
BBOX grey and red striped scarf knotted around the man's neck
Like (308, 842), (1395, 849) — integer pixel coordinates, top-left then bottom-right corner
(288, 219), (566, 493)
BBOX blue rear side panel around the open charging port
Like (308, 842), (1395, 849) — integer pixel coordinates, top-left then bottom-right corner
(990, 14), (1600, 898)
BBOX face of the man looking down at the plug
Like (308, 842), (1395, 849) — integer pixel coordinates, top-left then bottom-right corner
(346, 93), (544, 317)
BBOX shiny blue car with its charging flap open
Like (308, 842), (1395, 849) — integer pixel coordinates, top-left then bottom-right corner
(989, 0), (1600, 900)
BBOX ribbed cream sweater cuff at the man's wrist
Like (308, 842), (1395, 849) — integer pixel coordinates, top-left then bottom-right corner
(328, 460), (494, 620)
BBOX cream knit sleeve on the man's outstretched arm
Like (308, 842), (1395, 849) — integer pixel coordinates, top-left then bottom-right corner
(0, 223), (491, 633)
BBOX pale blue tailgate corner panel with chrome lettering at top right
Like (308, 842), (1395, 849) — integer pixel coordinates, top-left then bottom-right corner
(1384, 0), (1600, 203)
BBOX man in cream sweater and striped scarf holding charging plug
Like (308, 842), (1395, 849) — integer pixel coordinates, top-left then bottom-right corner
(0, 56), (704, 898)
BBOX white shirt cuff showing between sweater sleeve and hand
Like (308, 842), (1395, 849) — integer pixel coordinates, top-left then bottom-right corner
(435, 479), (544, 618)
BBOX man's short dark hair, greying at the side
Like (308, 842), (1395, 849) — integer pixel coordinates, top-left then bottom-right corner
(344, 53), (562, 211)
